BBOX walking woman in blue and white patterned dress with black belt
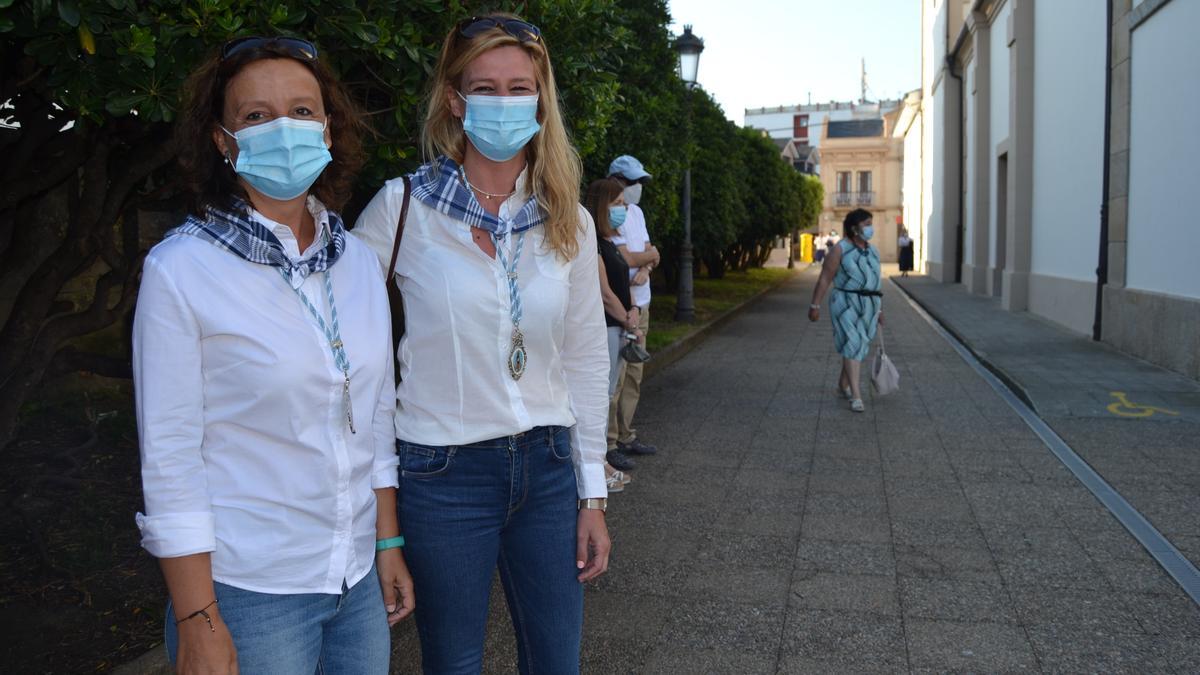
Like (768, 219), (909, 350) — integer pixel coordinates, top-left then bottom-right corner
(809, 209), (883, 412)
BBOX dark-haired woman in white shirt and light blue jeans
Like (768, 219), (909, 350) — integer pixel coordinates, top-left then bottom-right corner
(133, 37), (414, 674)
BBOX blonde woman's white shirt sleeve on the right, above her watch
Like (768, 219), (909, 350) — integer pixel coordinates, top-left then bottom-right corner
(562, 207), (608, 498)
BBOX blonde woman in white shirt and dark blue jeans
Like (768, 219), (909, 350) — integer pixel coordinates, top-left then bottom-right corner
(355, 13), (610, 674)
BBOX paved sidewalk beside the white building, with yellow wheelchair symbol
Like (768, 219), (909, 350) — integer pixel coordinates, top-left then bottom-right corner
(893, 276), (1200, 566)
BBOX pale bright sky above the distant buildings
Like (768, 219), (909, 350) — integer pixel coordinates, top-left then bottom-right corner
(668, 0), (922, 125)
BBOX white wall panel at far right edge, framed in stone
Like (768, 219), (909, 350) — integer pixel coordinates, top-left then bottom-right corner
(1126, 0), (1200, 299)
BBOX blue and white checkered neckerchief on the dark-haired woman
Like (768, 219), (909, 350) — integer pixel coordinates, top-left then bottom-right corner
(166, 198), (346, 289)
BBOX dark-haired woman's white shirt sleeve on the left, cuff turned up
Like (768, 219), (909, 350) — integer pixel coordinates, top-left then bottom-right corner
(133, 253), (216, 557)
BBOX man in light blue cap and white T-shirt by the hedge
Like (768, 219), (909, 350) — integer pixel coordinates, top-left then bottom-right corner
(607, 155), (660, 471)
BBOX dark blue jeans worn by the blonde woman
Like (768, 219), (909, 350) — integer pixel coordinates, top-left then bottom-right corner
(398, 426), (583, 675)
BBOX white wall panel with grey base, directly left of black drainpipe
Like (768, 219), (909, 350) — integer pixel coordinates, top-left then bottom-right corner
(1016, 0), (1106, 333)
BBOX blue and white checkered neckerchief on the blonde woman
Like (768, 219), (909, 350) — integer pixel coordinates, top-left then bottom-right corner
(413, 155), (545, 239)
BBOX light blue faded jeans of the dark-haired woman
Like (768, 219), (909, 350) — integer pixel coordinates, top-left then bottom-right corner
(166, 567), (391, 675)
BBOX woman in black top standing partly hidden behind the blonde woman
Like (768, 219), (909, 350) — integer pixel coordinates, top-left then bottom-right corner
(583, 178), (641, 492)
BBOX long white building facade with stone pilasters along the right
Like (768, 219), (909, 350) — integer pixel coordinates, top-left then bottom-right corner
(902, 0), (1200, 377)
